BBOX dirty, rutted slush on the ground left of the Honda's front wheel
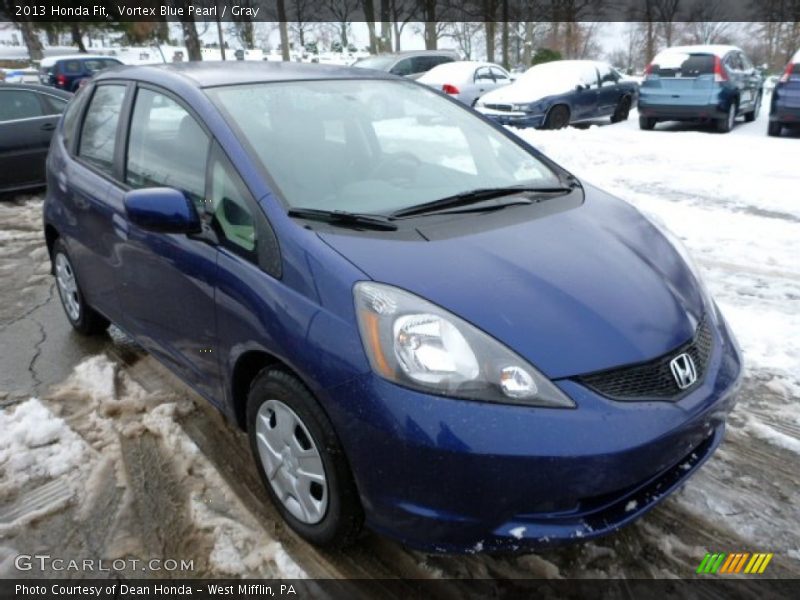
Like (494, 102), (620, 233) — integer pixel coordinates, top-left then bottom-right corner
(0, 355), (305, 578)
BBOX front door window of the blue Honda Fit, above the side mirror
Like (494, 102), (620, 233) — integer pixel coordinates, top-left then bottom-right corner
(125, 89), (209, 210)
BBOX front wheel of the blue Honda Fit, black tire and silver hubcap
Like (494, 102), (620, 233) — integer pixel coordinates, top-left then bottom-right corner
(247, 367), (364, 548)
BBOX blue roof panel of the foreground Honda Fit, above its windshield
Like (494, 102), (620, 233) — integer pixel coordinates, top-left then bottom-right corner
(95, 60), (396, 87)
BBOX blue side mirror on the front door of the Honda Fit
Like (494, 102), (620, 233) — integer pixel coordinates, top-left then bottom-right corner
(124, 188), (202, 233)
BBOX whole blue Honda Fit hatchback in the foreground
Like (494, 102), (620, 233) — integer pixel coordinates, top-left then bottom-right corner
(44, 63), (741, 552)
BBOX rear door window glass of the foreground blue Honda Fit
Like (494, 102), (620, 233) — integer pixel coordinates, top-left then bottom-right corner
(78, 85), (125, 174)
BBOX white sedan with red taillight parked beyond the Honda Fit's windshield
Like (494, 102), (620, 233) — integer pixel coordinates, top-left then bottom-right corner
(417, 61), (511, 106)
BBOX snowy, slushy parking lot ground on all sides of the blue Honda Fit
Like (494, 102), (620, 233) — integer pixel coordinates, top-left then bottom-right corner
(0, 105), (800, 580)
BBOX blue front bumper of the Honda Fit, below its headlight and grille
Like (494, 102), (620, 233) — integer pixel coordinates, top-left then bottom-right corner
(328, 304), (741, 552)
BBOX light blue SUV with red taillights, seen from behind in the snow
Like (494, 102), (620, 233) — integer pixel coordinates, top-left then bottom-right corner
(639, 45), (763, 133)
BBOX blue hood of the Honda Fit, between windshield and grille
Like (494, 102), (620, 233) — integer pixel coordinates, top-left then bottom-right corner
(319, 186), (703, 379)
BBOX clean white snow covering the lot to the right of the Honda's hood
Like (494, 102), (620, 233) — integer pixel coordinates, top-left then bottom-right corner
(520, 105), (800, 392)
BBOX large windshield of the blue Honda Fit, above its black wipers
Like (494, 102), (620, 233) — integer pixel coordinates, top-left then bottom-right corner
(206, 80), (563, 214)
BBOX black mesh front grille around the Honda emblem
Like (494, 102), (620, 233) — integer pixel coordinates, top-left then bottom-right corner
(578, 317), (713, 401)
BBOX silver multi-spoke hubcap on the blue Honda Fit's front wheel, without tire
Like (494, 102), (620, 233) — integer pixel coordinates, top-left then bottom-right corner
(256, 400), (328, 525)
